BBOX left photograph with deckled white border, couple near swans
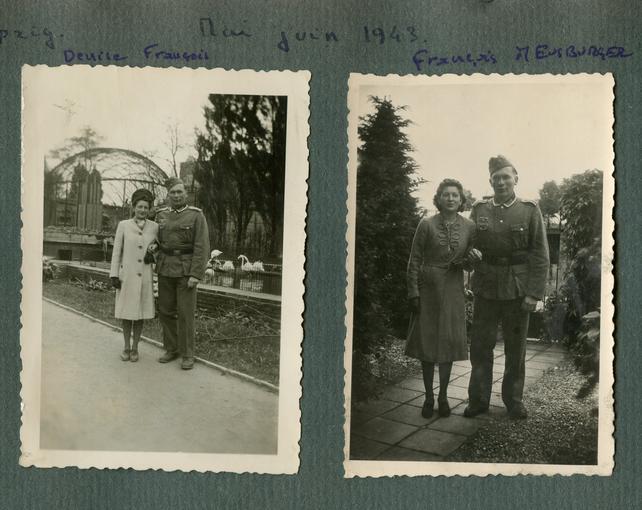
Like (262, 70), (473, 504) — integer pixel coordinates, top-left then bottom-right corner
(20, 65), (309, 474)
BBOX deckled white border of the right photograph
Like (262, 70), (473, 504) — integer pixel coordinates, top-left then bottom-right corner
(343, 73), (615, 478)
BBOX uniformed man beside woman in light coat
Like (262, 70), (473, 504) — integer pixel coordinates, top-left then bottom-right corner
(156, 177), (210, 370)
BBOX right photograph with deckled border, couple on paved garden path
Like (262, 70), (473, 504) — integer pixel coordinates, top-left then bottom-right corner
(344, 74), (614, 477)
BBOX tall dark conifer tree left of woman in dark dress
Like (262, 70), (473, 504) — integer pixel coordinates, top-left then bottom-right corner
(353, 97), (420, 352)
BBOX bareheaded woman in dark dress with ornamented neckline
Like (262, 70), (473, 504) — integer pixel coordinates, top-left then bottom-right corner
(406, 179), (475, 418)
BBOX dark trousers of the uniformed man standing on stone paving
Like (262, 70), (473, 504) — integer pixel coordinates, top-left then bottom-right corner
(468, 297), (529, 409)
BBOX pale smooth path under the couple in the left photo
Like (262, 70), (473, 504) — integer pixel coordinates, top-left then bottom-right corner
(40, 300), (278, 454)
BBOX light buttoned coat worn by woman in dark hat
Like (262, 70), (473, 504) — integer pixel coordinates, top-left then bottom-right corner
(109, 218), (158, 320)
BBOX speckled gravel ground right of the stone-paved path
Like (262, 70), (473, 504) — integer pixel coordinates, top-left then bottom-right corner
(445, 361), (598, 465)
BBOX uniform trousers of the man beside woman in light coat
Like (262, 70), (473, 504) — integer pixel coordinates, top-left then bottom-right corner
(158, 275), (196, 358)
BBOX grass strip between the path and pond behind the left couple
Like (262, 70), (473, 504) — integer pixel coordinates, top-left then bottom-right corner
(43, 280), (280, 385)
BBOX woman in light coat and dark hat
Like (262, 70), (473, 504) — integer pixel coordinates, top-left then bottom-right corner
(109, 189), (158, 361)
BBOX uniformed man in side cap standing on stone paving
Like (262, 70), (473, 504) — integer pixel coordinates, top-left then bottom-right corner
(464, 155), (549, 419)
